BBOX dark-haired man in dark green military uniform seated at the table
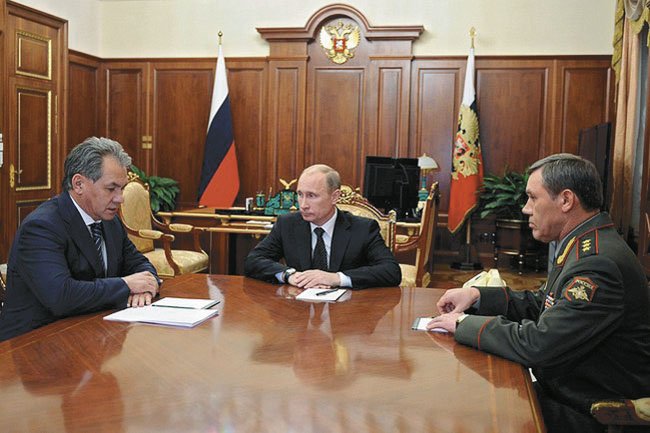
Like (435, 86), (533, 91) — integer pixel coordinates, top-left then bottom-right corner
(428, 154), (650, 433)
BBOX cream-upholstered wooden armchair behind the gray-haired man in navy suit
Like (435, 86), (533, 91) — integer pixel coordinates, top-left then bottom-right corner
(119, 173), (209, 278)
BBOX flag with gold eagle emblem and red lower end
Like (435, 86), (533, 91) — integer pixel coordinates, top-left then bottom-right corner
(447, 48), (483, 234)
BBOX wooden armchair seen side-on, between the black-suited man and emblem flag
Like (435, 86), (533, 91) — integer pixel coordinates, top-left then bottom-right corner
(394, 182), (440, 287)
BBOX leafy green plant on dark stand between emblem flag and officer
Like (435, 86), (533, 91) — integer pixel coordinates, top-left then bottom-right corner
(478, 168), (543, 273)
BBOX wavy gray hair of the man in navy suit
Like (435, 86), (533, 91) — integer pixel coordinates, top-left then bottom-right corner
(62, 137), (131, 191)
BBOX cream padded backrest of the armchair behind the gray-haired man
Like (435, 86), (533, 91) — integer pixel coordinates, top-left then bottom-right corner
(119, 173), (154, 253)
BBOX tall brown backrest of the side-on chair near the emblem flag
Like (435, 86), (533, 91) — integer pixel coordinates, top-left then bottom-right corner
(415, 182), (440, 287)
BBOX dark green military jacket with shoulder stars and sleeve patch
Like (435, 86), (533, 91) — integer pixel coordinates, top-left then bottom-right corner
(455, 213), (650, 413)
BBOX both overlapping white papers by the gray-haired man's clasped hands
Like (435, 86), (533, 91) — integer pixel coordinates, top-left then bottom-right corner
(104, 298), (219, 328)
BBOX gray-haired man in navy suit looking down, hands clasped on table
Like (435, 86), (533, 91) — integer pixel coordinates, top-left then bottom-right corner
(0, 137), (160, 341)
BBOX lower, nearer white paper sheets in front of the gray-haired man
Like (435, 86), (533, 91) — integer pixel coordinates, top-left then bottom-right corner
(104, 305), (219, 328)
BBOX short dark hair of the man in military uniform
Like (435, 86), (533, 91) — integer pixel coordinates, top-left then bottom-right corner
(528, 153), (603, 211)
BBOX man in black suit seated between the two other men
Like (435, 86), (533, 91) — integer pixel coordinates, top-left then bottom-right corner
(245, 164), (402, 289)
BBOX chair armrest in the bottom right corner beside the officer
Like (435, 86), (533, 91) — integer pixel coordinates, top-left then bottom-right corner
(591, 397), (650, 433)
